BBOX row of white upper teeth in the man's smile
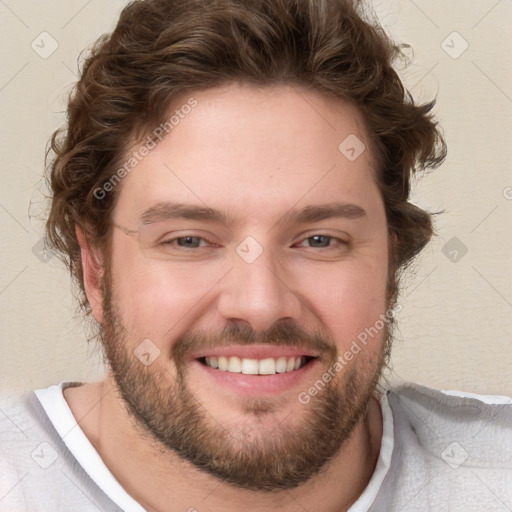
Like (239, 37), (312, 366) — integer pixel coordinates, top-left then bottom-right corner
(205, 356), (302, 375)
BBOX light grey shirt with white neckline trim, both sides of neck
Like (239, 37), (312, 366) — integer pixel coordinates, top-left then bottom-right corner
(0, 383), (512, 512)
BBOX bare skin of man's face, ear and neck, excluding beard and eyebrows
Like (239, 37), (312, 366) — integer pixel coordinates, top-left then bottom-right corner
(64, 84), (389, 512)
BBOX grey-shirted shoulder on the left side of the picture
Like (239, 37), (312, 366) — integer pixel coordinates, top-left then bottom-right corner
(0, 383), (120, 512)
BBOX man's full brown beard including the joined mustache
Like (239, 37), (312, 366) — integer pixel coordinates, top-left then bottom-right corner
(101, 268), (390, 492)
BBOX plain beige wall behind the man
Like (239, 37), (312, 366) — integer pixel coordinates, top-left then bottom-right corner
(0, 0), (512, 395)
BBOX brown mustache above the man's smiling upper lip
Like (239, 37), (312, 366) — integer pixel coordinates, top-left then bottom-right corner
(171, 320), (337, 368)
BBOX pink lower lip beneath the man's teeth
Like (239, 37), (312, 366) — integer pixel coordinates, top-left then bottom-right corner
(194, 359), (318, 396)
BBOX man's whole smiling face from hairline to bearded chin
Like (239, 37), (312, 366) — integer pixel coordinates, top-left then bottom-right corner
(97, 84), (388, 490)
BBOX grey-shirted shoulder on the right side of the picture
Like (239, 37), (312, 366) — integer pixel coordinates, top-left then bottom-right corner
(371, 383), (512, 512)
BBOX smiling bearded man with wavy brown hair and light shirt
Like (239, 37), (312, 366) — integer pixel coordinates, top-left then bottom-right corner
(0, 0), (512, 512)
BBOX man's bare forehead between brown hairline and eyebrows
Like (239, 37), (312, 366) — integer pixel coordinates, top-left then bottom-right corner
(116, 84), (382, 224)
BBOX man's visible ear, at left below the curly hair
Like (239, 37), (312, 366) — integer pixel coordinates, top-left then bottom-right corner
(76, 226), (104, 323)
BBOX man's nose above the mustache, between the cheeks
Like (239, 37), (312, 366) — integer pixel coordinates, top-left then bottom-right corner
(218, 243), (304, 331)
